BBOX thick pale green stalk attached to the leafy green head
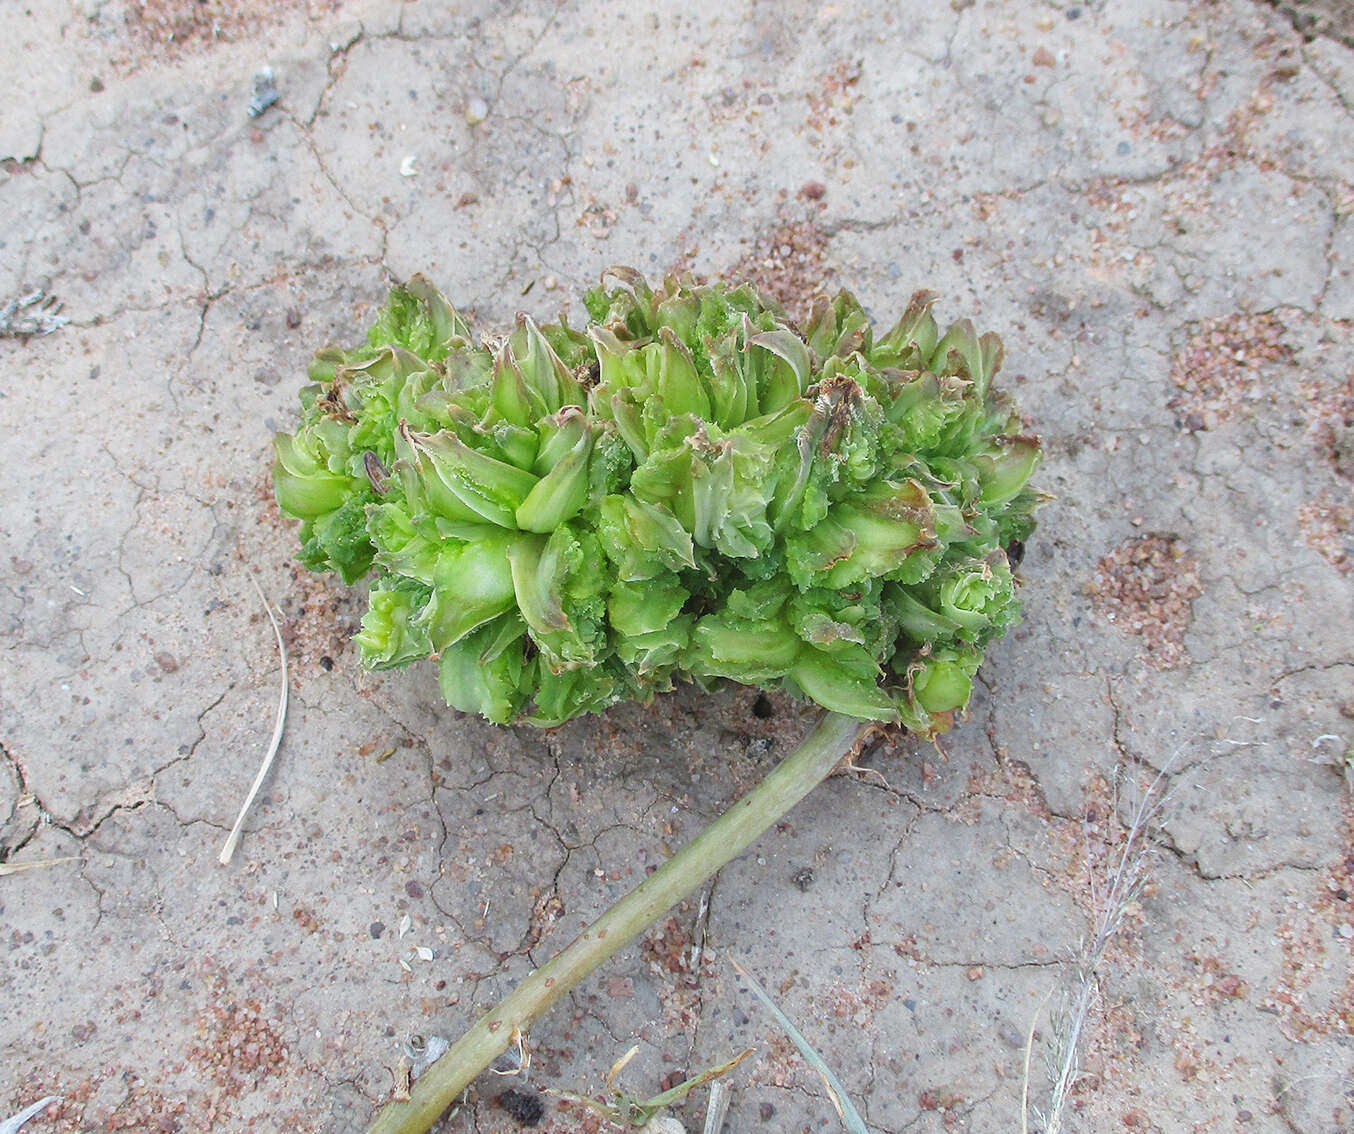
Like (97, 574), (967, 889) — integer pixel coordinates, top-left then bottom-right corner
(367, 713), (873, 1134)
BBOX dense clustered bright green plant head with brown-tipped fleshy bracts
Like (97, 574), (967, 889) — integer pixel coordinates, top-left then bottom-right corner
(274, 268), (1040, 735)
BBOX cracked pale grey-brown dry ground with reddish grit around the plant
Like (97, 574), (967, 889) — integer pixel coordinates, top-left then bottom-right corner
(0, 0), (1354, 1134)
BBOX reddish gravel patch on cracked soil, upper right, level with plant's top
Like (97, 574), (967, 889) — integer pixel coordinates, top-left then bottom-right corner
(1167, 311), (1293, 433)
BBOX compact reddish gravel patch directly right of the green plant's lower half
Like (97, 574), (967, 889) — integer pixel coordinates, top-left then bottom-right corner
(1087, 535), (1204, 670)
